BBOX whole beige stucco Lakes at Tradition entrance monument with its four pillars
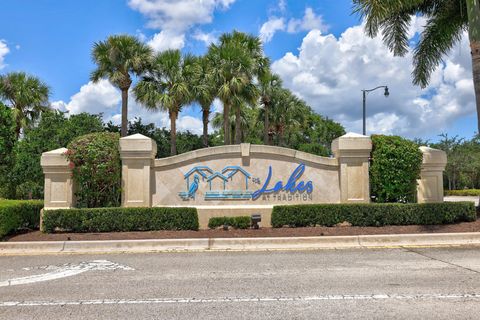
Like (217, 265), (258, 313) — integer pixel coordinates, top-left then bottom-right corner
(42, 133), (446, 228)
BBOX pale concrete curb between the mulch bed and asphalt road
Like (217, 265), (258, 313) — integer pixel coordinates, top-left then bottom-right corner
(0, 232), (480, 256)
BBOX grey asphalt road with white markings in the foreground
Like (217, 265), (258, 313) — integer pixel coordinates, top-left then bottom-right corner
(0, 247), (480, 320)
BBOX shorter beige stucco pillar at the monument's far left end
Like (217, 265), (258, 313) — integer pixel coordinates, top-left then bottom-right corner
(40, 148), (75, 210)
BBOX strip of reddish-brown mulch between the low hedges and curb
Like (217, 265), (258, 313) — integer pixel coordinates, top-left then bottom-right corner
(4, 219), (480, 241)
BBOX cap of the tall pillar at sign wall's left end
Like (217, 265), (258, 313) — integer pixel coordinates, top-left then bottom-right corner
(120, 133), (157, 158)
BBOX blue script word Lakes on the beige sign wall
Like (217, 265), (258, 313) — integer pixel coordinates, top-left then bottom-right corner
(252, 163), (313, 200)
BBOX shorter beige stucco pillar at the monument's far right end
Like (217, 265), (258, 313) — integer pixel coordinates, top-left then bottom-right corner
(417, 147), (447, 203)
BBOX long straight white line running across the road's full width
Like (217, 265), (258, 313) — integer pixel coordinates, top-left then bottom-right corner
(0, 293), (480, 307)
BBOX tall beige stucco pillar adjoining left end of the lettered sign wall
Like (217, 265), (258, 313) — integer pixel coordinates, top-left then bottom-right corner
(120, 134), (157, 207)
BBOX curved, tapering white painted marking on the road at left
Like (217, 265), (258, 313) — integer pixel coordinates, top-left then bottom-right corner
(0, 260), (134, 287)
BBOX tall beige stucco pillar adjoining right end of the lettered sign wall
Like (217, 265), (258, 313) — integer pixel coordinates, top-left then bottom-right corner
(332, 132), (372, 203)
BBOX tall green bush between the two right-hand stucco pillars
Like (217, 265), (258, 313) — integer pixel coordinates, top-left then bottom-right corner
(370, 135), (422, 203)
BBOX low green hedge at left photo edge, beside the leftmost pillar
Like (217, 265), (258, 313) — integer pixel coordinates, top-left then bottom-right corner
(0, 200), (43, 238)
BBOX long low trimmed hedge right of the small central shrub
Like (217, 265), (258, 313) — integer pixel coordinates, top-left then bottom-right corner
(272, 202), (477, 228)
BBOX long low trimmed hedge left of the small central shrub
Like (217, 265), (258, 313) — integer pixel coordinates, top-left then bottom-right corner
(42, 207), (198, 233)
